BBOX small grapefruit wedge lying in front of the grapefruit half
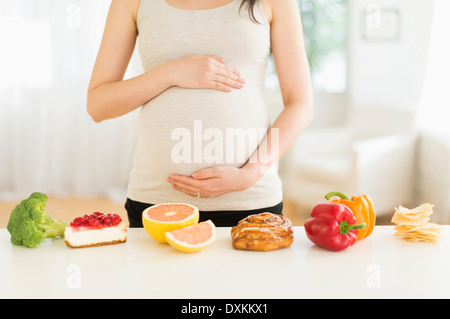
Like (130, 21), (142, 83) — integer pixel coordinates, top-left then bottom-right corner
(166, 220), (216, 253)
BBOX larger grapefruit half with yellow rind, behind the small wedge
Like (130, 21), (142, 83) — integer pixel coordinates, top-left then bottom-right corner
(142, 203), (199, 243)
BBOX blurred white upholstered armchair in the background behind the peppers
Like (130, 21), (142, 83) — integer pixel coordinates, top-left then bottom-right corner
(284, 107), (416, 216)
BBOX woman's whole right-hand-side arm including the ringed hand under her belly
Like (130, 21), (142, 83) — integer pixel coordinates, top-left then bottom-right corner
(167, 0), (313, 197)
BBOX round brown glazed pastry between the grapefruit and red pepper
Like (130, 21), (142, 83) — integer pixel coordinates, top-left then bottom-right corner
(231, 213), (294, 251)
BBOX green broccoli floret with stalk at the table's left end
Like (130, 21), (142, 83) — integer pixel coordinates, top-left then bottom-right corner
(7, 192), (68, 248)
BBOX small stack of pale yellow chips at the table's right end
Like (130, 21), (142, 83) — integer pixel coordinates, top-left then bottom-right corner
(392, 204), (440, 242)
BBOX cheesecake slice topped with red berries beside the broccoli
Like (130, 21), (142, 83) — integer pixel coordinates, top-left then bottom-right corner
(64, 212), (127, 248)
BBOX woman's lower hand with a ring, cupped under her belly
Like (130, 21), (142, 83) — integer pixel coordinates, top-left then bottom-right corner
(167, 166), (254, 198)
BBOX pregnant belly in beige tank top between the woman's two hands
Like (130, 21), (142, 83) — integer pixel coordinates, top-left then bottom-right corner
(135, 88), (270, 180)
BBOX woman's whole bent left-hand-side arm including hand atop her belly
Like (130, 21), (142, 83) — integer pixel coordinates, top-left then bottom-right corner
(87, 0), (244, 122)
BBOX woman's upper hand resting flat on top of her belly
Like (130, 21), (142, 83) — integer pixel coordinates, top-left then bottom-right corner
(170, 54), (245, 92)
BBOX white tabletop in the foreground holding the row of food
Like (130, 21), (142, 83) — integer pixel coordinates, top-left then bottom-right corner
(0, 226), (450, 299)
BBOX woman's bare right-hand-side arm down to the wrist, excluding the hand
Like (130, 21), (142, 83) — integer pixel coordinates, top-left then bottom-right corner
(239, 0), (313, 182)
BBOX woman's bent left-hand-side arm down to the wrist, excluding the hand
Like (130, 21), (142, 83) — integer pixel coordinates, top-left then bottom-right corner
(87, 0), (154, 122)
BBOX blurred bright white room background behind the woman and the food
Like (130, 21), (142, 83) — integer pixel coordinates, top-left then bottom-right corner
(0, 0), (450, 228)
